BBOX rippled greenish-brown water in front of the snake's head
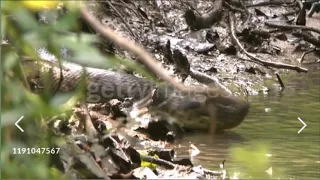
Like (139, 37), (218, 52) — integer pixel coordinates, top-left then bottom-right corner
(179, 64), (320, 178)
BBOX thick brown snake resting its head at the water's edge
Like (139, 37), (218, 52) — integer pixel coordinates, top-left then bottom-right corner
(22, 50), (250, 132)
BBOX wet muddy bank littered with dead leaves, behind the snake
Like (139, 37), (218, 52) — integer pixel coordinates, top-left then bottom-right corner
(87, 0), (320, 96)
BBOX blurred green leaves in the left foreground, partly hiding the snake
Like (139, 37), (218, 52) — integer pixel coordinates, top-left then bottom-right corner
(1, 1), (116, 179)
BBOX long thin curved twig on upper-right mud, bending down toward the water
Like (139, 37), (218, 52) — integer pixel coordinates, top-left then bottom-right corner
(229, 12), (308, 72)
